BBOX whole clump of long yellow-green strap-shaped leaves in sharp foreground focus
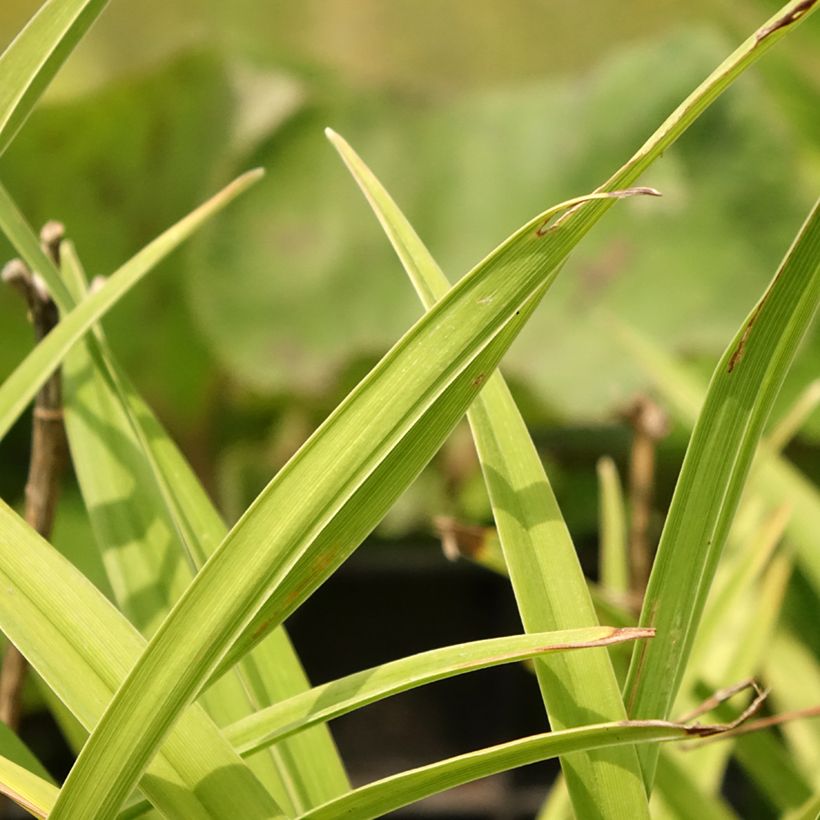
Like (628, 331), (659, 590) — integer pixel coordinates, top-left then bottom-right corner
(0, 0), (820, 818)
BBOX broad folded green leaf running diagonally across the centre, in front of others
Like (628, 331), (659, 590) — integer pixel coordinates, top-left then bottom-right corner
(54, 187), (580, 816)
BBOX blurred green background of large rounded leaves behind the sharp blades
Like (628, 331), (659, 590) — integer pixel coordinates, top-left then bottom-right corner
(0, 0), (820, 816)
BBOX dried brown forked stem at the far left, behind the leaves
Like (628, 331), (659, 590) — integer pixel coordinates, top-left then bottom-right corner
(0, 222), (66, 731)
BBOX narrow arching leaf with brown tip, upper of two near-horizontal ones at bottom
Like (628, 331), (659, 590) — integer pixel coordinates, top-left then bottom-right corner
(225, 626), (652, 755)
